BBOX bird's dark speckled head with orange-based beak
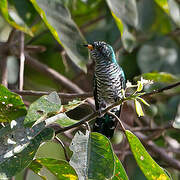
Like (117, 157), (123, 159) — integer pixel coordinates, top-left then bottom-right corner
(84, 41), (116, 63)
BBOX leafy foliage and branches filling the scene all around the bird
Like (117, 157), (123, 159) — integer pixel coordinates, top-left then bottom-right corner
(0, 0), (180, 180)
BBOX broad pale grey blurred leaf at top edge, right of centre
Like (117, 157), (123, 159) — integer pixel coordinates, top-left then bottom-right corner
(106, 0), (138, 27)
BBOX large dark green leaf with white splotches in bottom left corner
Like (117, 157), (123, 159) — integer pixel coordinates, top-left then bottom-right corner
(0, 118), (54, 178)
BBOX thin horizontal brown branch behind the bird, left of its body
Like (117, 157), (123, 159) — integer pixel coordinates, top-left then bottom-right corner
(11, 89), (93, 99)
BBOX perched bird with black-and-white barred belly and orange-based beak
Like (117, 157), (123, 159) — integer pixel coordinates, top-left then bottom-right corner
(84, 41), (125, 139)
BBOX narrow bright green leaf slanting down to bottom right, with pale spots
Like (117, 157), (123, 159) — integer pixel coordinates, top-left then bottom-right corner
(125, 130), (170, 180)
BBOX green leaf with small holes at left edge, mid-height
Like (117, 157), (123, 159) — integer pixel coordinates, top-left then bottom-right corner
(0, 85), (26, 122)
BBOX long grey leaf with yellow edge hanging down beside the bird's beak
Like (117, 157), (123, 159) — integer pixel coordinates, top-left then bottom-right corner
(31, 0), (88, 70)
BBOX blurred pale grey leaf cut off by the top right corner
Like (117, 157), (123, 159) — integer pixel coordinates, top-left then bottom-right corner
(167, 0), (180, 27)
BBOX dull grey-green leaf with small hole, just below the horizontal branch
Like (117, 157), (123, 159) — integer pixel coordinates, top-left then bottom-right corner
(24, 92), (61, 126)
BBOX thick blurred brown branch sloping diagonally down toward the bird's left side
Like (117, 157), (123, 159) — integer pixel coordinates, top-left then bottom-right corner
(25, 53), (84, 93)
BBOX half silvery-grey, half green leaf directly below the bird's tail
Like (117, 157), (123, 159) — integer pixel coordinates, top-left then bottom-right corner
(69, 131), (114, 180)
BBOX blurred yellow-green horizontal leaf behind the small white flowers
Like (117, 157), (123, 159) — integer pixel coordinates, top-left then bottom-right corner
(135, 72), (178, 83)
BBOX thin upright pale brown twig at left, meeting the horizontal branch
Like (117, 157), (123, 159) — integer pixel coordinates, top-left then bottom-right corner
(19, 32), (25, 91)
